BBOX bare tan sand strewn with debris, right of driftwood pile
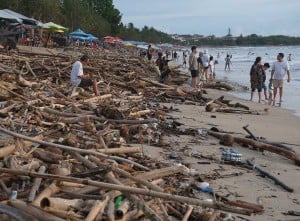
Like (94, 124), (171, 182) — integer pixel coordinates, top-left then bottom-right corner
(144, 84), (300, 221)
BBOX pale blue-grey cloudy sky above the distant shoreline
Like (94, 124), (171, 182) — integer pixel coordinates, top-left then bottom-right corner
(114, 0), (300, 36)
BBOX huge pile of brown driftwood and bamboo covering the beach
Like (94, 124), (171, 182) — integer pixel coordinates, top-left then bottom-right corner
(0, 47), (263, 221)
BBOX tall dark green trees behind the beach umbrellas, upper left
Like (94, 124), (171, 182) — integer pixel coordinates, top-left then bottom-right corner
(0, 0), (172, 43)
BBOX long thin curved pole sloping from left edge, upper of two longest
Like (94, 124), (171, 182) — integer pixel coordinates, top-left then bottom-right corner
(0, 127), (149, 171)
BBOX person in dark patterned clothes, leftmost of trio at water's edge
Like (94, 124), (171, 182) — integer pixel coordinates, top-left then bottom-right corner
(250, 57), (263, 103)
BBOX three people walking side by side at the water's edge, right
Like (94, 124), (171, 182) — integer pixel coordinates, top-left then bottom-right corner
(250, 53), (291, 106)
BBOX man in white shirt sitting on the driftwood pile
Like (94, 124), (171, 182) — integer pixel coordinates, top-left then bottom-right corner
(71, 55), (99, 96)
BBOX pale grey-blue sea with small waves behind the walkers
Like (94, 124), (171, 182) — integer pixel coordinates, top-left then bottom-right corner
(180, 46), (300, 116)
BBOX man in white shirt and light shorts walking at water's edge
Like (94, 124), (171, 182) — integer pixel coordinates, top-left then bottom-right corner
(271, 53), (291, 106)
